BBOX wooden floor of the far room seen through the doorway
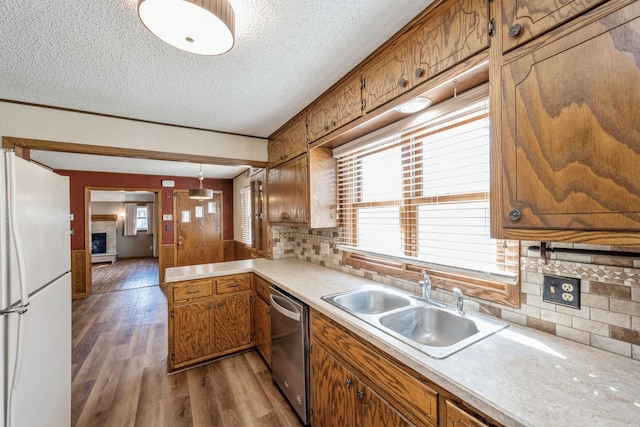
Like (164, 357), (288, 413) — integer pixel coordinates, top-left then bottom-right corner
(91, 257), (158, 294)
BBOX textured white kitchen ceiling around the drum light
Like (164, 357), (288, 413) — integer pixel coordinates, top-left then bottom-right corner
(0, 0), (433, 137)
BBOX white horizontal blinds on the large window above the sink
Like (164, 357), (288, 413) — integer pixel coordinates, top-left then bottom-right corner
(334, 84), (518, 283)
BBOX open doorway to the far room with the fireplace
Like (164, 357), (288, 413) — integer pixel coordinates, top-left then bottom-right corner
(85, 188), (161, 296)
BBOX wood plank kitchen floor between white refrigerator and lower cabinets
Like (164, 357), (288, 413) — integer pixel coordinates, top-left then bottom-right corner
(71, 286), (301, 427)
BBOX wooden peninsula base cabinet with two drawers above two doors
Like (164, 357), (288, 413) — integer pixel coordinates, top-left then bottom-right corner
(167, 273), (254, 371)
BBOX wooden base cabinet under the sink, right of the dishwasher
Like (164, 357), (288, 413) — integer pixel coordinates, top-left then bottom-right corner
(310, 309), (499, 427)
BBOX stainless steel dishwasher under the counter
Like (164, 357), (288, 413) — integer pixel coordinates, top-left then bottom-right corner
(269, 286), (309, 425)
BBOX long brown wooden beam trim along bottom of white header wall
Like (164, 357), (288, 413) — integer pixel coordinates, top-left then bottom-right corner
(2, 136), (267, 168)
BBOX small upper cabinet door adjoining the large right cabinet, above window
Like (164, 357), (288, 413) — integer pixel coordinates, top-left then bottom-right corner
(407, 0), (489, 86)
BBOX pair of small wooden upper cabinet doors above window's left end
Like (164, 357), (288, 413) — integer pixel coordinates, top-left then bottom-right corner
(307, 76), (362, 142)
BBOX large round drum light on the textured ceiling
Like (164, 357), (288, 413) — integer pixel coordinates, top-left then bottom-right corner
(138, 0), (235, 55)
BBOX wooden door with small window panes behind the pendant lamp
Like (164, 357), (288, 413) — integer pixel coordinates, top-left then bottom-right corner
(173, 190), (224, 266)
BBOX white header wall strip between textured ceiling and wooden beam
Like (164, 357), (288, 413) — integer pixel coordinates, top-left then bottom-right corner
(0, 102), (267, 162)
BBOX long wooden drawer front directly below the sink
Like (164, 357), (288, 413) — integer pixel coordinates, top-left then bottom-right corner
(310, 311), (438, 426)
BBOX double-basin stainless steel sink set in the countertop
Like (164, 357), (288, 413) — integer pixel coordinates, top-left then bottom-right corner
(322, 285), (508, 359)
